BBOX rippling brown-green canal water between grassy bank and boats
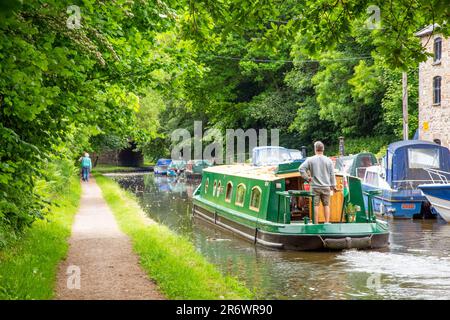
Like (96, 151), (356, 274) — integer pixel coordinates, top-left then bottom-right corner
(109, 174), (450, 299)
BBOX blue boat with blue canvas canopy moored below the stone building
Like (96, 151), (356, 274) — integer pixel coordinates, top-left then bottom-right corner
(362, 140), (450, 218)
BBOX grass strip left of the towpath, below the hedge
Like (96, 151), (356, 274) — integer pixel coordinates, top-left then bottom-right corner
(0, 177), (81, 299)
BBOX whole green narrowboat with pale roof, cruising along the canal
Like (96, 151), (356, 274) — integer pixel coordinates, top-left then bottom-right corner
(192, 148), (389, 250)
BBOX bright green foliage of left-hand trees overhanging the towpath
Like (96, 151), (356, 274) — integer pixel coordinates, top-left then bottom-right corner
(0, 0), (201, 232)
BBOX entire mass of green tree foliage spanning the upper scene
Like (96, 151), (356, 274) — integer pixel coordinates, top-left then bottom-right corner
(0, 0), (436, 238)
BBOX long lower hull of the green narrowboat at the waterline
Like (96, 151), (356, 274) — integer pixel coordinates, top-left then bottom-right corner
(192, 196), (389, 251)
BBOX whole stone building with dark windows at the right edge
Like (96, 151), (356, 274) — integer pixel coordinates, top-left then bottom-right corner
(416, 24), (450, 148)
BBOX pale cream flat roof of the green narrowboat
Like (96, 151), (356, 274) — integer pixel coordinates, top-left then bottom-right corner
(203, 164), (316, 181)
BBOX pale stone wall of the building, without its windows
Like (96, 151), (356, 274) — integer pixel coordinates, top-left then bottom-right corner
(419, 34), (450, 148)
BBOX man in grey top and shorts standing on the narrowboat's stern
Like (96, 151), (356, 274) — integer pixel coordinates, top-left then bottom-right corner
(299, 141), (336, 224)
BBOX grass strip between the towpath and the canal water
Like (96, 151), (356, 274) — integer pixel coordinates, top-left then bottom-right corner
(96, 174), (253, 299)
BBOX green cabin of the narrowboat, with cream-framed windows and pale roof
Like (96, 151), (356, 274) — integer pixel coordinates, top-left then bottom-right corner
(200, 162), (365, 224)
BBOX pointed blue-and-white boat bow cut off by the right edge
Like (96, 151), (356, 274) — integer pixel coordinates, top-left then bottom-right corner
(418, 169), (450, 222)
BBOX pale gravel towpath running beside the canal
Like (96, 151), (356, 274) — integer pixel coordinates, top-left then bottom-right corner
(56, 180), (164, 300)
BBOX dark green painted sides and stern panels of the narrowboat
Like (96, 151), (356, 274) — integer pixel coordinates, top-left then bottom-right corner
(194, 165), (388, 236)
